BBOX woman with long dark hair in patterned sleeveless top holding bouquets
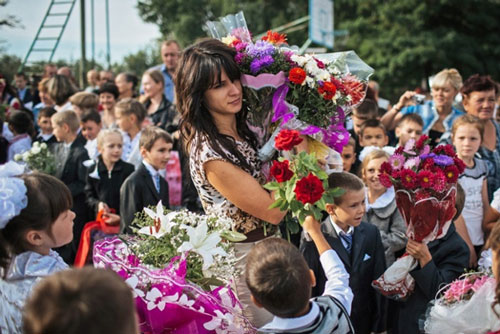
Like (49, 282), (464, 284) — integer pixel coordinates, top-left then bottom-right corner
(175, 39), (285, 326)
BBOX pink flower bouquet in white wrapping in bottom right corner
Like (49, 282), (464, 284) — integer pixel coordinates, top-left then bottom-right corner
(425, 272), (500, 334)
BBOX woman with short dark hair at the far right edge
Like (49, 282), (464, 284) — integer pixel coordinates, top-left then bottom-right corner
(460, 74), (500, 201)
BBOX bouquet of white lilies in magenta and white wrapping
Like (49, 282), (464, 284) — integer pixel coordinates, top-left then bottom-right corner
(94, 202), (253, 334)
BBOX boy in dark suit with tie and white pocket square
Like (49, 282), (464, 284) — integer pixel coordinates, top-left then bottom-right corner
(300, 172), (386, 334)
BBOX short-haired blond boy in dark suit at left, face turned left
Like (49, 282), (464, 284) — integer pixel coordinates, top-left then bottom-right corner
(52, 110), (90, 264)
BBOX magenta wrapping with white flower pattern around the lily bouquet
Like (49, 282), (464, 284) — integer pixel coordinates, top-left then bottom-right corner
(94, 237), (253, 334)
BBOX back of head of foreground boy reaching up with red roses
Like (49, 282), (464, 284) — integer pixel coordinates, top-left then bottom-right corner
(245, 238), (312, 318)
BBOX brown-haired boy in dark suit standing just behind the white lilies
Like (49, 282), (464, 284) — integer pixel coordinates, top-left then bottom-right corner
(120, 126), (173, 233)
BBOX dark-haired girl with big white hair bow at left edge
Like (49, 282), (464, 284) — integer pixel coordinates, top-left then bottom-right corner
(0, 162), (75, 333)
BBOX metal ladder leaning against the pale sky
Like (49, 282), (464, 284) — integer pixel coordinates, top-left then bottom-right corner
(19, 0), (77, 71)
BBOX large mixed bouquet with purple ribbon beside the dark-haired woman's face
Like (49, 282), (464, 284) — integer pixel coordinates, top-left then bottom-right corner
(207, 12), (373, 161)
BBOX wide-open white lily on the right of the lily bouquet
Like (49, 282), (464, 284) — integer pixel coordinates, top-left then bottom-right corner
(177, 222), (227, 270)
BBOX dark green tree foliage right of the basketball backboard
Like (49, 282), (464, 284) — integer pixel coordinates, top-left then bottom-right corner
(335, 0), (500, 100)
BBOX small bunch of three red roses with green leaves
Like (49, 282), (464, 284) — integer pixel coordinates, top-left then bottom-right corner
(264, 130), (343, 228)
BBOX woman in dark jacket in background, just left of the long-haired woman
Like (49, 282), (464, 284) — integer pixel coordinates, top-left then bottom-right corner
(142, 70), (179, 134)
